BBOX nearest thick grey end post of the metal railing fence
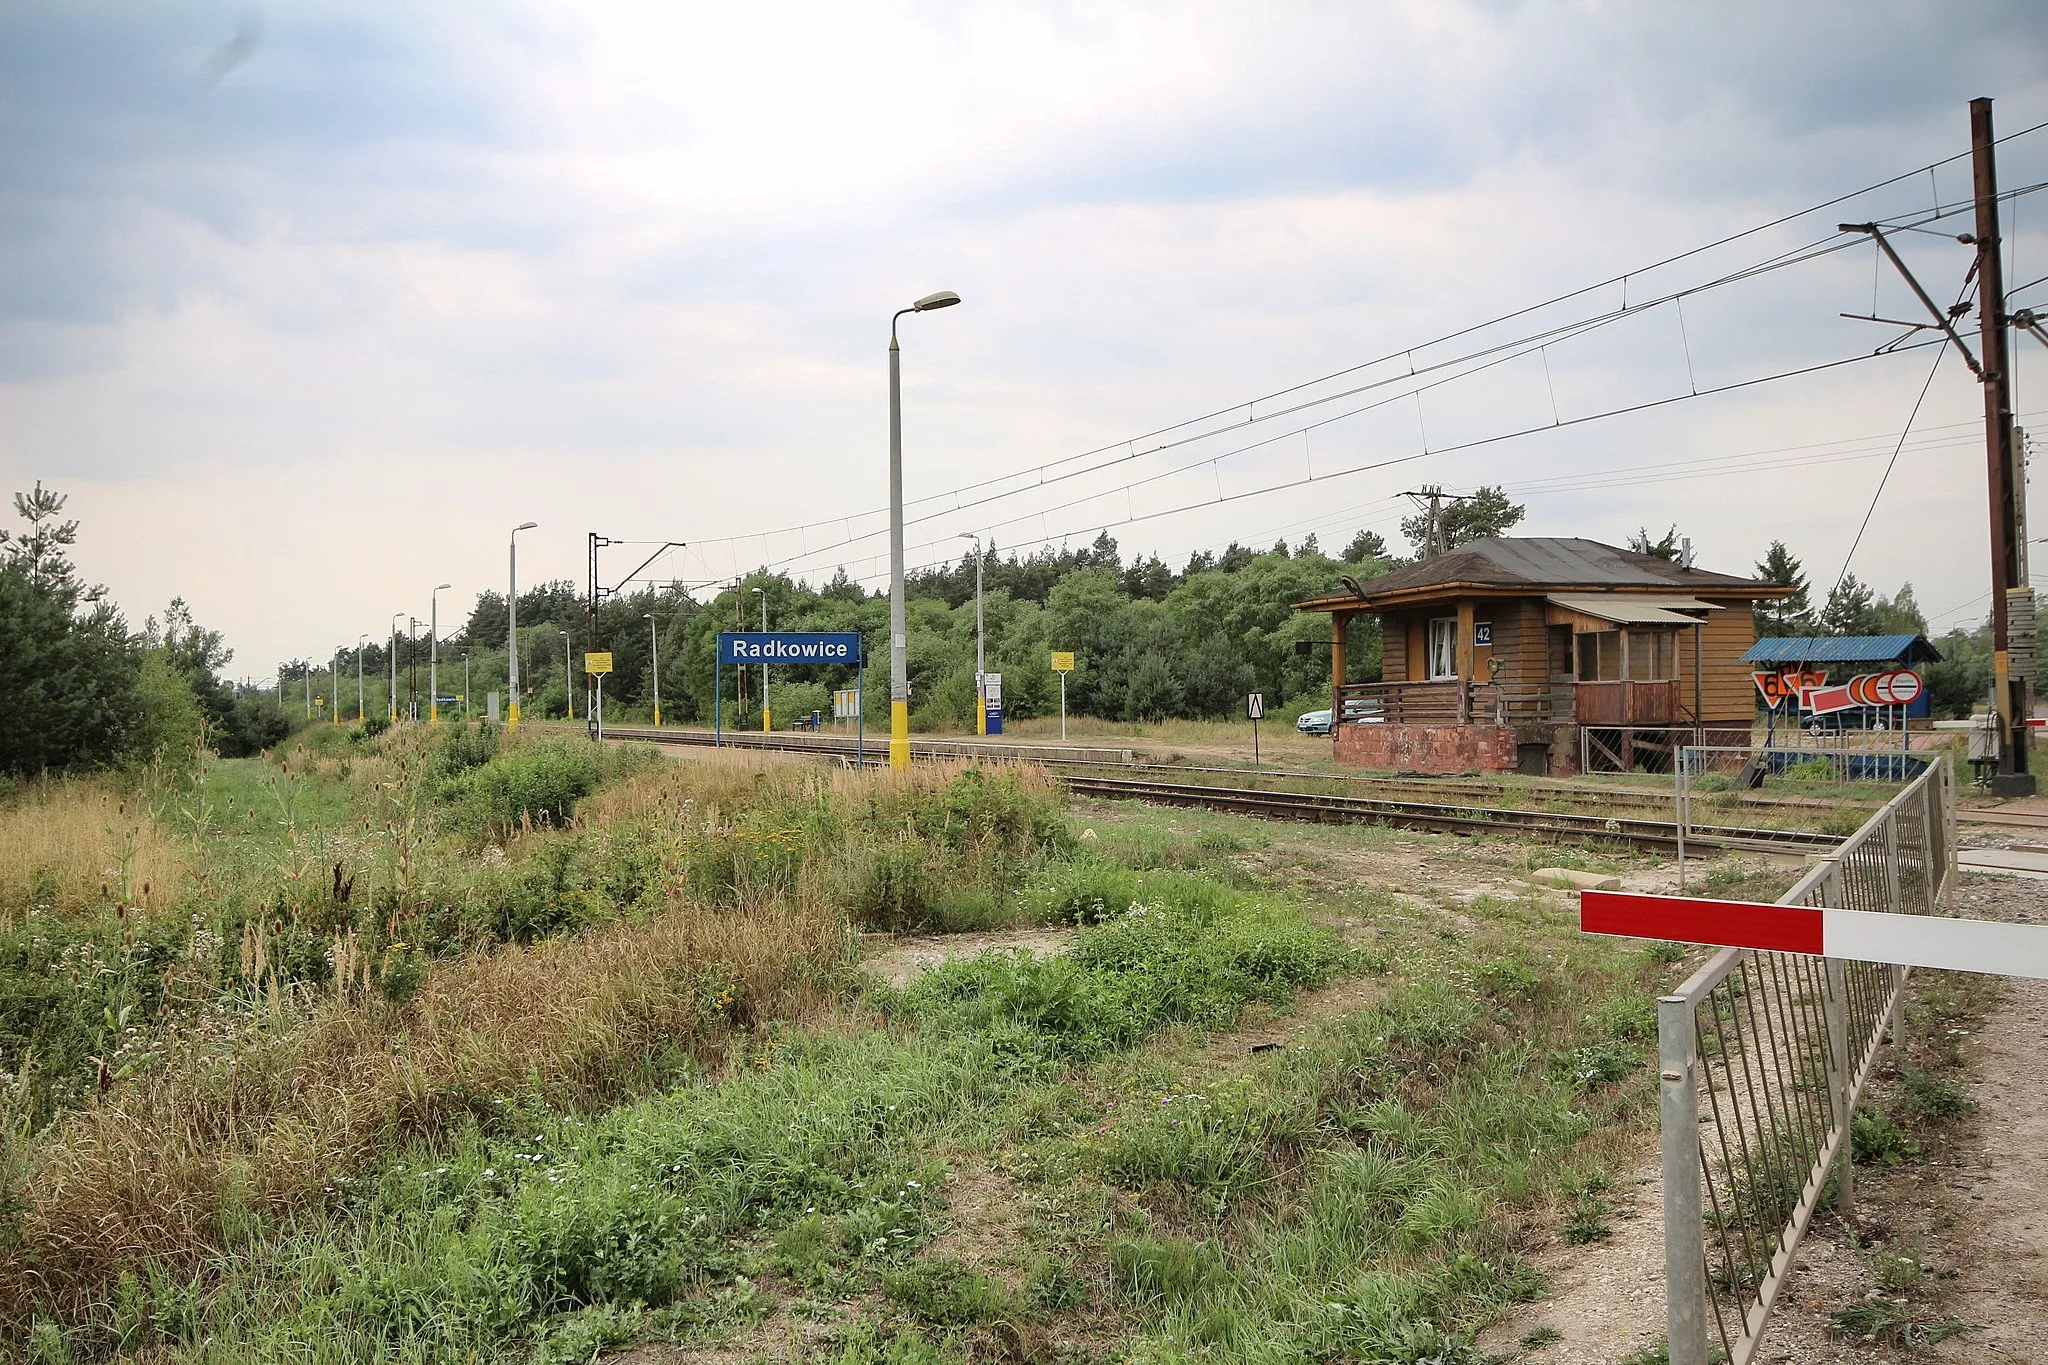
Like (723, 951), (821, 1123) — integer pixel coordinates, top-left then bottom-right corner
(1657, 995), (1706, 1365)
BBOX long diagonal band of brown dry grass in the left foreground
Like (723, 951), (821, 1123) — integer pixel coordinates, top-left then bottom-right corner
(0, 888), (856, 1324)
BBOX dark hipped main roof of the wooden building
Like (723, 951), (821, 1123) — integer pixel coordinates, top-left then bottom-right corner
(1300, 536), (1782, 610)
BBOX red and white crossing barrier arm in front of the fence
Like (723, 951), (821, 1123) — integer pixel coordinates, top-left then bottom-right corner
(1579, 890), (2048, 978)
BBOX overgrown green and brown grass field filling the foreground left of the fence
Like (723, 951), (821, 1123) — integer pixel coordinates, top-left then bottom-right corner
(0, 726), (1728, 1361)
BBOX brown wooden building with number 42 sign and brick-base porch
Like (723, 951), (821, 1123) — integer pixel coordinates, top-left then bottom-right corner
(1294, 536), (1790, 774)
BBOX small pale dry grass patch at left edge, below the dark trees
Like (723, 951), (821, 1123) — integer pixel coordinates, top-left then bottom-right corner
(0, 778), (190, 927)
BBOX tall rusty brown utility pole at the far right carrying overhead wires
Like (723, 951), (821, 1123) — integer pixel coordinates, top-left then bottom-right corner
(1970, 98), (2034, 796)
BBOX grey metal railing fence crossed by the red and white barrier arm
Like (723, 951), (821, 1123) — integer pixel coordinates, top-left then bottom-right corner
(1657, 759), (1956, 1365)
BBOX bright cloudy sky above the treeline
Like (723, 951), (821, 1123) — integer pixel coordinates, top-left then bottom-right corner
(0, 0), (2048, 677)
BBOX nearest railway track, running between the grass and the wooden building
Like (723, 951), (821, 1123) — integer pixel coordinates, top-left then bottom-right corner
(606, 729), (1839, 853)
